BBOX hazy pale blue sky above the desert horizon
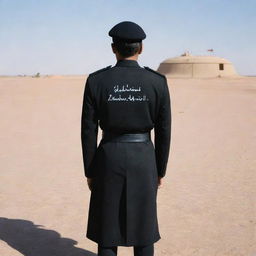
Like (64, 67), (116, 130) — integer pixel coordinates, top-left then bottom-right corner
(0, 0), (256, 75)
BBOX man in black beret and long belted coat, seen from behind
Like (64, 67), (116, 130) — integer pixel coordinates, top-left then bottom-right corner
(81, 21), (171, 256)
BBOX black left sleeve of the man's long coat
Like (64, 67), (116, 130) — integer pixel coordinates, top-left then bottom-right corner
(81, 77), (98, 178)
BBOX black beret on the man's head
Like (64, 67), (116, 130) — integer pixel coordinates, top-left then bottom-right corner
(108, 21), (146, 42)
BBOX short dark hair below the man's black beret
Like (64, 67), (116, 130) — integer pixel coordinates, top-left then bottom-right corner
(113, 40), (142, 57)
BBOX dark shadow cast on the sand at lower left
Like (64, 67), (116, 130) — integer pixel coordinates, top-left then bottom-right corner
(0, 217), (97, 256)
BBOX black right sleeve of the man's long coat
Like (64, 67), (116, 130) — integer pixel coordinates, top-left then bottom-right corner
(154, 77), (172, 177)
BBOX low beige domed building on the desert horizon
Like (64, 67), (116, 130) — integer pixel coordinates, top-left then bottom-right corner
(157, 52), (238, 78)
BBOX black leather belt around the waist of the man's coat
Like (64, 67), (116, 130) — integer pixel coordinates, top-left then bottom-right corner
(102, 131), (151, 142)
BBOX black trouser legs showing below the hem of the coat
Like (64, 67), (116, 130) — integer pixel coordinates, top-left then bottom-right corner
(98, 244), (154, 256)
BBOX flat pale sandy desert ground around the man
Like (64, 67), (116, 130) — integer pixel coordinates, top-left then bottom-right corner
(0, 76), (256, 256)
